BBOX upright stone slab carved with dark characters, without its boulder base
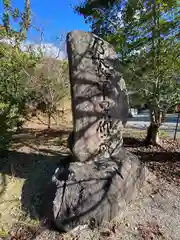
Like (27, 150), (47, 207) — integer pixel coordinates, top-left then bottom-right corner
(67, 31), (128, 161)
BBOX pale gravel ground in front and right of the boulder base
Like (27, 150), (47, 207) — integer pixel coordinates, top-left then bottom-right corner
(28, 176), (180, 240)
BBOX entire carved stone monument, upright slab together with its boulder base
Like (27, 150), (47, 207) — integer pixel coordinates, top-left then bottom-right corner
(45, 31), (145, 231)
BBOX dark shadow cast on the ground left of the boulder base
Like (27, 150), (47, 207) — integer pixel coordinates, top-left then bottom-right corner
(0, 151), (70, 219)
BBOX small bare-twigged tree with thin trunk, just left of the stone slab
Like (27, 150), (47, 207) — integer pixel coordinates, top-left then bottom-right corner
(29, 58), (69, 129)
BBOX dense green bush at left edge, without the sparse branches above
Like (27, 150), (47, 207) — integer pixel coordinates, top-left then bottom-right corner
(0, 43), (38, 153)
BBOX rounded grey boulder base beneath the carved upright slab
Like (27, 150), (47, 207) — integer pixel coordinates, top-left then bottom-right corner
(46, 149), (145, 231)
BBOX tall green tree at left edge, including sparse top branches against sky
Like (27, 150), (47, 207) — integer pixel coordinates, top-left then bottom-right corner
(0, 0), (38, 152)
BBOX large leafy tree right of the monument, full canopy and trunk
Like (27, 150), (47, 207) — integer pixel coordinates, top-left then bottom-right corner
(76, 0), (180, 144)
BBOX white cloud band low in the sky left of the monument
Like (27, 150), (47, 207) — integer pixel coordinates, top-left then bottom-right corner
(0, 38), (66, 59)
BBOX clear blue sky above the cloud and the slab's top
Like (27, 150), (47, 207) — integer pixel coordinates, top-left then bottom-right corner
(0, 0), (90, 45)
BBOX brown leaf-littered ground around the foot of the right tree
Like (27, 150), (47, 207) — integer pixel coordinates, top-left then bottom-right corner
(124, 137), (180, 185)
